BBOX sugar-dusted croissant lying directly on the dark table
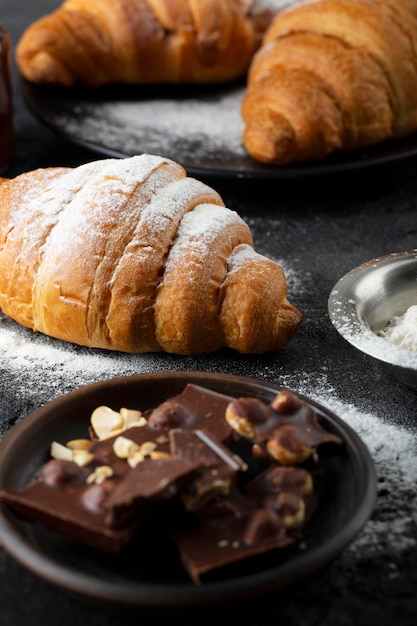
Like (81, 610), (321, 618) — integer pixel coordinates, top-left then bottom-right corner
(0, 154), (302, 354)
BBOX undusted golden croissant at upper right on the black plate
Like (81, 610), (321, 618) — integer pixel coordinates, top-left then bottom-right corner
(242, 0), (417, 165)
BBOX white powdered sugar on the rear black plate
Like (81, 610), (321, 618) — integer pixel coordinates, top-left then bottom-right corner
(57, 86), (246, 163)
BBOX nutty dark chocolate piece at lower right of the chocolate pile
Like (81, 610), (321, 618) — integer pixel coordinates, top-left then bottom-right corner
(173, 464), (322, 585)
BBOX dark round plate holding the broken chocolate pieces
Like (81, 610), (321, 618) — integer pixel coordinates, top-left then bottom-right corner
(0, 372), (376, 611)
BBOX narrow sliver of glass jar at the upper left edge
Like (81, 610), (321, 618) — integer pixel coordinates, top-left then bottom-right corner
(0, 24), (14, 173)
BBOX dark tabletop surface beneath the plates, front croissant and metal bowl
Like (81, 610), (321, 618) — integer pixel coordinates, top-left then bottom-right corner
(0, 0), (417, 626)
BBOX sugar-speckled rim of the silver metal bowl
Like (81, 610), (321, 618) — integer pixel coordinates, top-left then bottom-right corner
(327, 248), (417, 372)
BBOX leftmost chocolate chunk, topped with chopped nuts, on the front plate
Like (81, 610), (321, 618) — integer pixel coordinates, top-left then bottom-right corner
(0, 450), (199, 552)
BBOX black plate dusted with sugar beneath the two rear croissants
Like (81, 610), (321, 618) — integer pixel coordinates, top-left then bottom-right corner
(22, 80), (417, 178)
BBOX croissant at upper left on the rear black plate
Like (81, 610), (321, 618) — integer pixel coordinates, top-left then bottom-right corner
(16, 0), (276, 87)
